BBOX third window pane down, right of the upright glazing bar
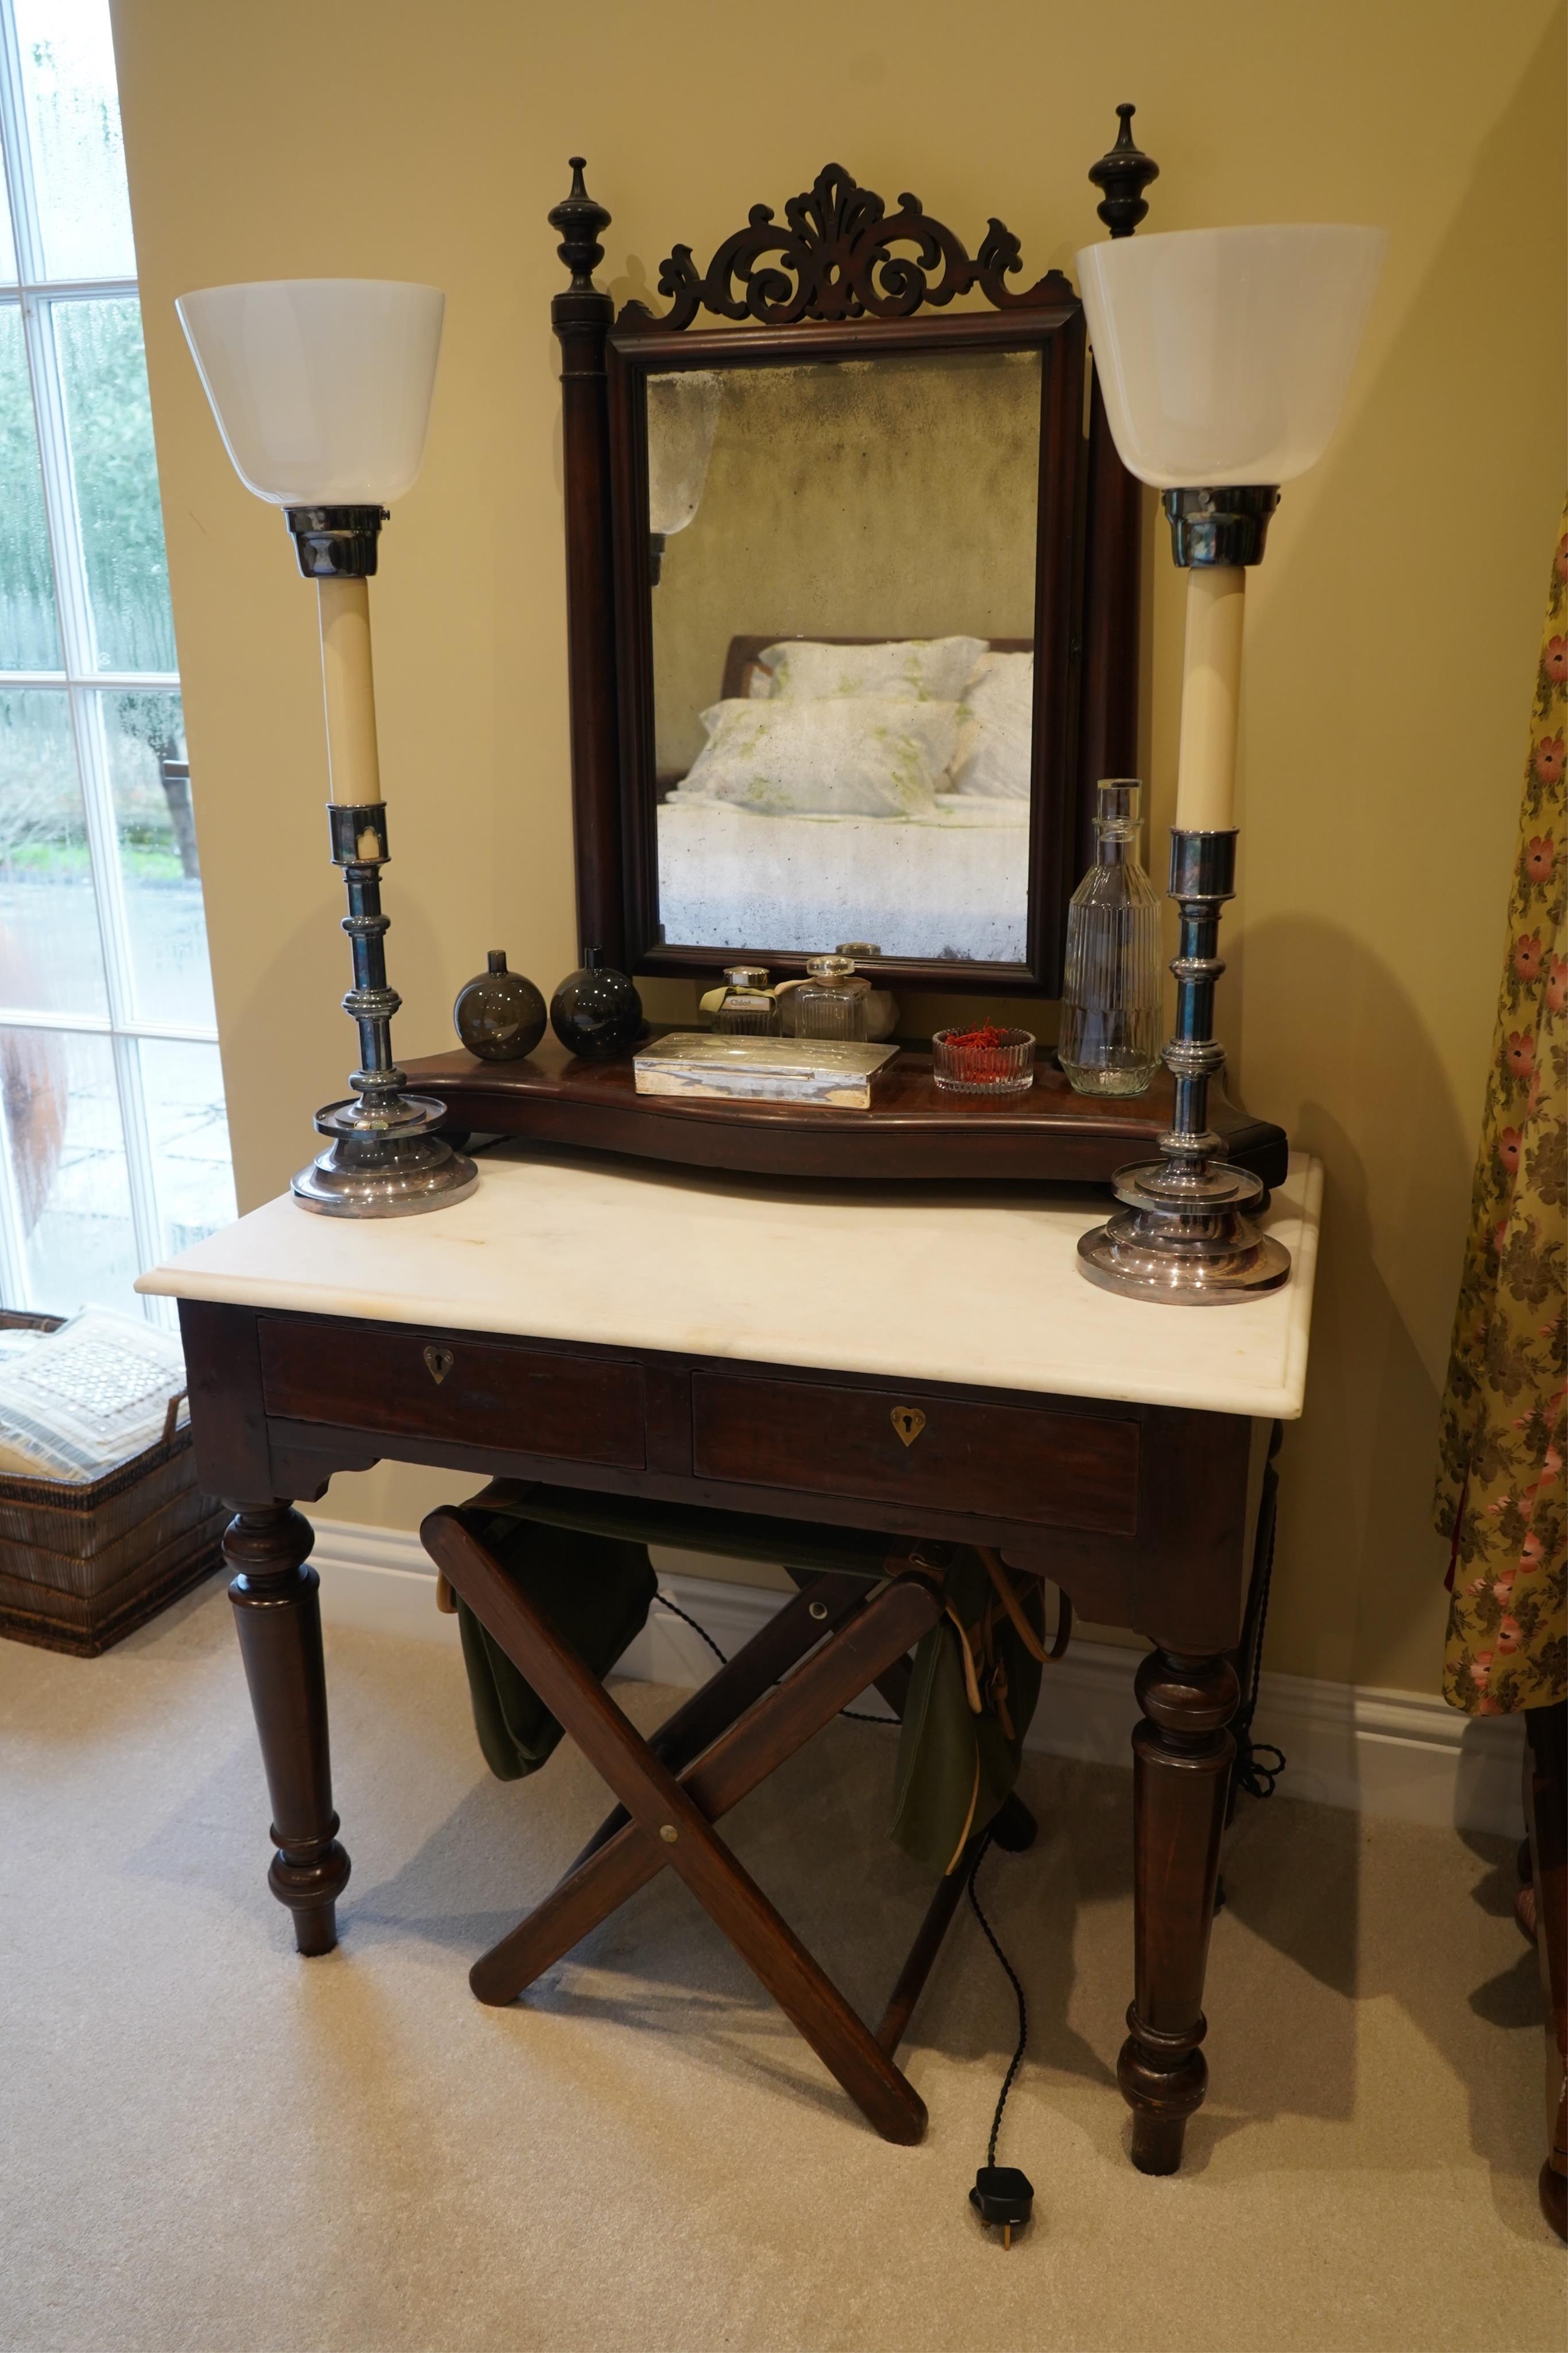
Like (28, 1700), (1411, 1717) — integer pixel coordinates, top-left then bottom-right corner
(94, 694), (217, 1028)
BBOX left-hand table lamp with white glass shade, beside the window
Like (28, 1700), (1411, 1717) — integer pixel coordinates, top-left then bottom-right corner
(174, 277), (480, 1217)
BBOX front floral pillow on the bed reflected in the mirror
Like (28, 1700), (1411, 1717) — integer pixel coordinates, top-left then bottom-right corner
(670, 694), (959, 816)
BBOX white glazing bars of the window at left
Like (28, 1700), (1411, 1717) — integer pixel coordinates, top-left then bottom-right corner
(0, 0), (219, 1322)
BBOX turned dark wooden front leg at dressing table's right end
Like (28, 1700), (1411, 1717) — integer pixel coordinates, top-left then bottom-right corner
(1117, 1649), (1241, 2174)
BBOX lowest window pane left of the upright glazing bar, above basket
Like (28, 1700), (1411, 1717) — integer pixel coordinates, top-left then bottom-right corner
(0, 1028), (141, 1316)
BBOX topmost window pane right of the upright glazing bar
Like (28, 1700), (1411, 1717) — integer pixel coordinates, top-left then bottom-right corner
(17, 0), (136, 277)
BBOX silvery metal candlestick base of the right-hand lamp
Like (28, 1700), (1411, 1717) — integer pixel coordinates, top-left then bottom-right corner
(1079, 828), (1291, 1308)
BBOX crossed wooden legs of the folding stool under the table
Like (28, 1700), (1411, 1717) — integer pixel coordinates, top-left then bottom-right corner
(421, 1509), (964, 2143)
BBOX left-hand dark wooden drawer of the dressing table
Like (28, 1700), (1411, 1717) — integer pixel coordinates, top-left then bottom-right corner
(258, 1316), (644, 1471)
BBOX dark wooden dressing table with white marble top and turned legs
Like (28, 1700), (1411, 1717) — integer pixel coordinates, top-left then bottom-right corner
(138, 1144), (1321, 2172)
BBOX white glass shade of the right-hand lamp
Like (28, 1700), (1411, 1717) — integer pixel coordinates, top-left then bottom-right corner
(1077, 226), (1387, 489)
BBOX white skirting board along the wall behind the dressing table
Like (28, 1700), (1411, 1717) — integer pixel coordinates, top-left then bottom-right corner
(310, 1520), (1523, 1838)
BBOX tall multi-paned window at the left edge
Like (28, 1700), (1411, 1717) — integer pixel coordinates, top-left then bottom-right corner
(0, 0), (235, 1313)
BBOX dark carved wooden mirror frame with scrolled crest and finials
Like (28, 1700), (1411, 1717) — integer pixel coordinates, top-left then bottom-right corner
(550, 124), (1157, 998)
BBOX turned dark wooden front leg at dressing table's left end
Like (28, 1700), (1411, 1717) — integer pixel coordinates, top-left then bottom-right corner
(223, 1501), (348, 1953)
